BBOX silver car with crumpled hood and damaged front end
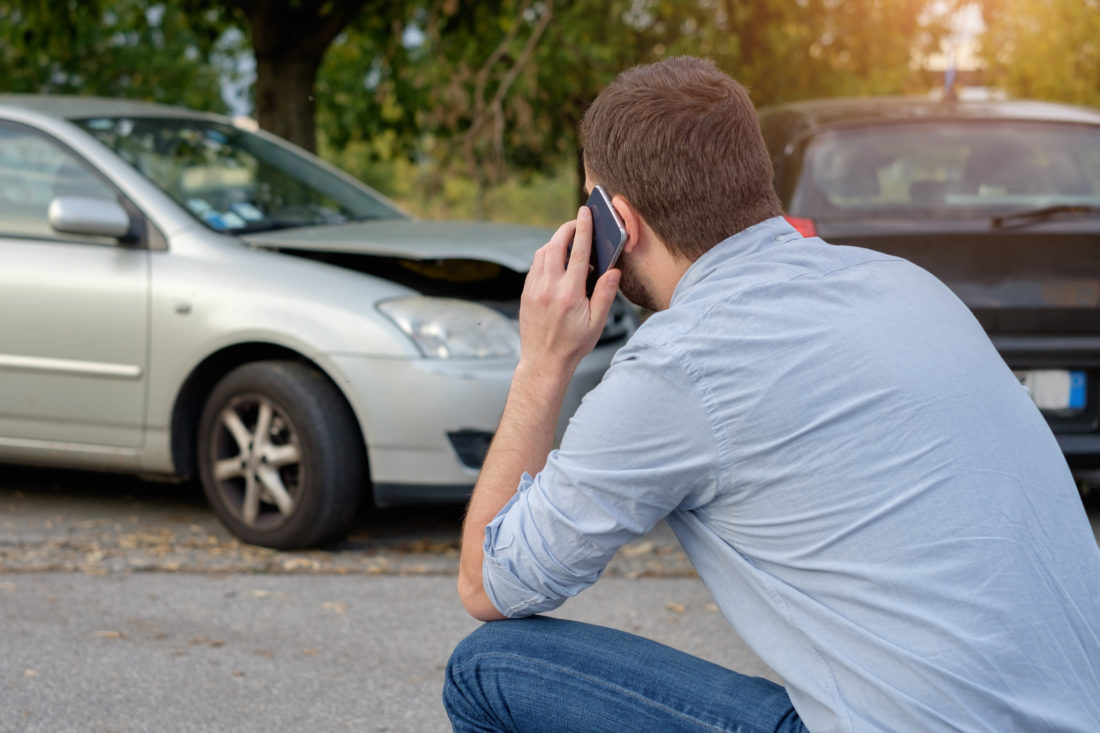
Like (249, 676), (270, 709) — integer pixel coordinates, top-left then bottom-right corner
(0, 96), (635, 548)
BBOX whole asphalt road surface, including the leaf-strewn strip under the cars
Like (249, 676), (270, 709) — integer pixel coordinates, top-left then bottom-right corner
(0, 466), (1100, 733)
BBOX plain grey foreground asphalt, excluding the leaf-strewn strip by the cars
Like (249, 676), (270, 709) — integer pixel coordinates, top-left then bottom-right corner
(0, 572), (767, 733)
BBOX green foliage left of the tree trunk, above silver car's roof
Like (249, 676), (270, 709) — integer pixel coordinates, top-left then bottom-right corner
(0, 0), (239, 111)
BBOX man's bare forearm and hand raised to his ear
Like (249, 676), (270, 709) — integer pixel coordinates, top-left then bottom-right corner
(459, 207), (619, 621)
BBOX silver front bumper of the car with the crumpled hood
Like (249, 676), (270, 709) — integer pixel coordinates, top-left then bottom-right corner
(329, 341), (624, 506)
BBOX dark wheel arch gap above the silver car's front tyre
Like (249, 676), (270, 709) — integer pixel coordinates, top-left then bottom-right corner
(171, 341), (373, 501)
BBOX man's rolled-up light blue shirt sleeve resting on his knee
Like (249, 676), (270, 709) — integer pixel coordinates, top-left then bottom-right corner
(482, 338), (718, 617)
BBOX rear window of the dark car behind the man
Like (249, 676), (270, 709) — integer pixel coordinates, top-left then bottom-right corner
(790, 121), (1100, 219)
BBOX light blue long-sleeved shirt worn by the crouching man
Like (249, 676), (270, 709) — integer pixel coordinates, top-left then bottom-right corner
(484, 218), (1100, 733)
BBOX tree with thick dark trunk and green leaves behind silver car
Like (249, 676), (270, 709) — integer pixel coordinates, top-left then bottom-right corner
(0, 0), (404, 150)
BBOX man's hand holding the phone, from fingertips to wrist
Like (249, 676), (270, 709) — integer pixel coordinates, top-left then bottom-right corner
(519, 206), (619, 382)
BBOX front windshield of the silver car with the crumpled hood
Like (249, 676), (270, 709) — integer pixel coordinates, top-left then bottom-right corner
(74, 117), (404, 233)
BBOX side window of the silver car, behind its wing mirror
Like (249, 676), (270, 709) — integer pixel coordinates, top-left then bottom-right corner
(0, 123), (118, 242)
